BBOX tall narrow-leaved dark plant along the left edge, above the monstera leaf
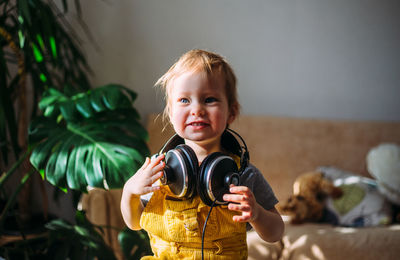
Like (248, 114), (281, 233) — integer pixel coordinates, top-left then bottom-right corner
(0, 0), (90, 231)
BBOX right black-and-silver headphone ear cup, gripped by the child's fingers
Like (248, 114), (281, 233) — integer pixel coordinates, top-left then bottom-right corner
(197, 152), (240, 206)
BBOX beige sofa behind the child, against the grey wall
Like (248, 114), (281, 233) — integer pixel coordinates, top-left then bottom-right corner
(82, 115), (400, 260)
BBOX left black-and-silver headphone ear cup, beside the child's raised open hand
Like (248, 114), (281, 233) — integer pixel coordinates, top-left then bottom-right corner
(161, 145), (198, 198)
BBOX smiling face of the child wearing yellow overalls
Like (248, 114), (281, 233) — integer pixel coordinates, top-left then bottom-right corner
(169, 72), (234, 146)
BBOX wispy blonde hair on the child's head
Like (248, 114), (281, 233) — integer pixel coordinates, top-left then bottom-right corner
(155, 49), (240, 124)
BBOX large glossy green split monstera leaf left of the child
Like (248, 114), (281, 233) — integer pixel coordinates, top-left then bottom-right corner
(29, 85), (149, 191)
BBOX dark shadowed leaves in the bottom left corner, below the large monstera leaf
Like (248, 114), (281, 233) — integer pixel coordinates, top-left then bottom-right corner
(0, 211), (116, 260)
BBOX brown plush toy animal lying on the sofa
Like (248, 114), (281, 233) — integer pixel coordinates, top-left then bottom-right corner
(279, 171), (342, 224)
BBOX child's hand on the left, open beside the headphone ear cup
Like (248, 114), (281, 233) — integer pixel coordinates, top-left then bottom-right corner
(124, 154), (165, 195)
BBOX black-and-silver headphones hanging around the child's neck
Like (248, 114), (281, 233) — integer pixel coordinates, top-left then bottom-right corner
(160, 128), (249, 206)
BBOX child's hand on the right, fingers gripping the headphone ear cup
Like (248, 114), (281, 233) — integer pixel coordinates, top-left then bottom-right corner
(223, 185), (258, 222)
